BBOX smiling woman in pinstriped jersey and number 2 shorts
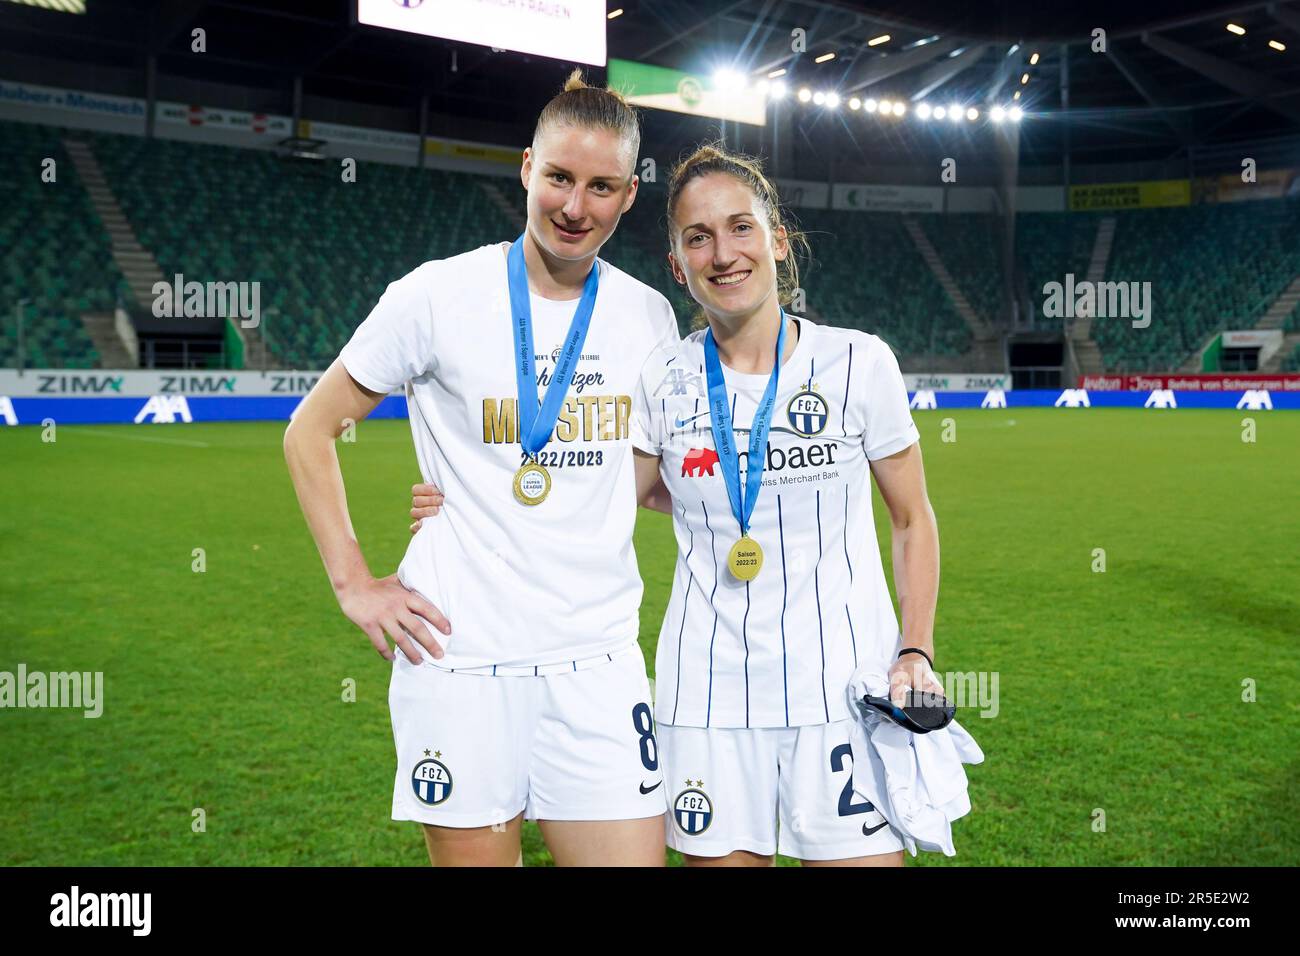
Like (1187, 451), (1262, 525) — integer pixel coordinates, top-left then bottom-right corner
(621, 146), (943, 866)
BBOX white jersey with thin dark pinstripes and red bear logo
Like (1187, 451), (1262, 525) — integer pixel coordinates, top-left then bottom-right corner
(633, 316), (919, 727)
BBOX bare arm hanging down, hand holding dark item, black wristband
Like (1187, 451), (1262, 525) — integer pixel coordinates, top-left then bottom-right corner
(871, 444), (943, 705)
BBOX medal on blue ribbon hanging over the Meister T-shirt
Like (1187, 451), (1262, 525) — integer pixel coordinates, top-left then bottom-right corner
(506, 235), (601, 505)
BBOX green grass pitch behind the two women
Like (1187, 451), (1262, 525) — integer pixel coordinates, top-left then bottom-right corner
(0, 408), (1300, 866)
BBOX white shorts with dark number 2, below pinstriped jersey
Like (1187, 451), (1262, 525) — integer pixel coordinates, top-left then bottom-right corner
(658, 721), (904, 860)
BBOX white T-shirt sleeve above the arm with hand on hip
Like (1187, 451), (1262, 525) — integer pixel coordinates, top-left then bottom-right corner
(339, 263), (434, 393)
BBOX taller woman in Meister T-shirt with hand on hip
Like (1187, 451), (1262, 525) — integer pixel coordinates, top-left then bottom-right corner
(285, 73), (677, 866)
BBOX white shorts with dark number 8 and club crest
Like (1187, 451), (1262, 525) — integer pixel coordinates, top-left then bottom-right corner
(389, 644), (667, 827)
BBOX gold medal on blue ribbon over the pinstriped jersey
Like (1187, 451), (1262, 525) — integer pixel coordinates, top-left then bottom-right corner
(705, 308), (785, 581)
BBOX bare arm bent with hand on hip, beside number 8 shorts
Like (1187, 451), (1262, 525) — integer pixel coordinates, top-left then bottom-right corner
(285, 359), (451, 661)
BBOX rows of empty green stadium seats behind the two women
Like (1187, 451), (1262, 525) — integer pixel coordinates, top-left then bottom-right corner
(10, 122), (1300, 369)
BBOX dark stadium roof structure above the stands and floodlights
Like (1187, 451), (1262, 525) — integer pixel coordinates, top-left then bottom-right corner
(0, 0), (1300, 161)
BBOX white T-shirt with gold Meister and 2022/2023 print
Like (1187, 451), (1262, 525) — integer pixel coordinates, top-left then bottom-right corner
(339, 245), (679, 672)
